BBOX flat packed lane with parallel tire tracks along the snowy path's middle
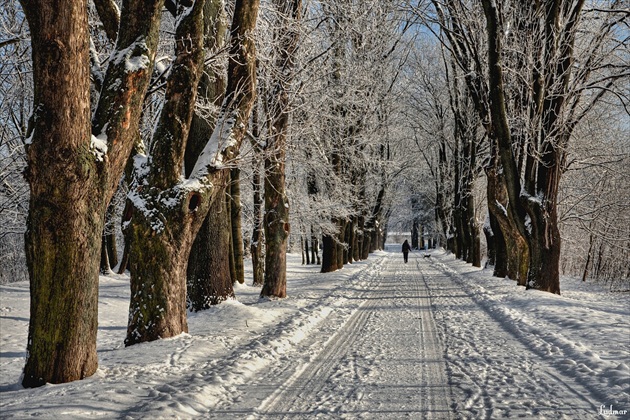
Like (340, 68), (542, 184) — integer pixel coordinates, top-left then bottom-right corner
(258, 254), (454, 420)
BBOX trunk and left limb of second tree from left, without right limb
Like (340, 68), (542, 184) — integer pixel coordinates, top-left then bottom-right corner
(125, 3), (216, 340)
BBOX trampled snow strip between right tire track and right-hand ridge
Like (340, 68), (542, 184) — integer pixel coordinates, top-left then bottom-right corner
(420, 254), (597, 419)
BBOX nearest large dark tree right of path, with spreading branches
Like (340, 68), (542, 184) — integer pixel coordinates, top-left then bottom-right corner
(482, 0), (628, 293)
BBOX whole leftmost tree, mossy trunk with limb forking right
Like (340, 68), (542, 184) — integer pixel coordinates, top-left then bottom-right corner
(21, 0), (163, 387)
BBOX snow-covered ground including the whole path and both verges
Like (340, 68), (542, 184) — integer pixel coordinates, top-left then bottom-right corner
(0, 246), (630, 419)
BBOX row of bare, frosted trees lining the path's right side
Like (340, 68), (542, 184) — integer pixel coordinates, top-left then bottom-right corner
(404, 0), (630, 293)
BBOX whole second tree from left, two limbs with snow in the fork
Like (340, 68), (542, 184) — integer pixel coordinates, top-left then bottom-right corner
(125, 0), (259, 345)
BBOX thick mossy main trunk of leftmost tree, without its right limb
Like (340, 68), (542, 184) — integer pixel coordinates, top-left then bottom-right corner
(21, 0), (97, 387)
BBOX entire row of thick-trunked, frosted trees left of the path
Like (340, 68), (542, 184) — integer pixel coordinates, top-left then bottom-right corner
(2, 0), (411, 387)
